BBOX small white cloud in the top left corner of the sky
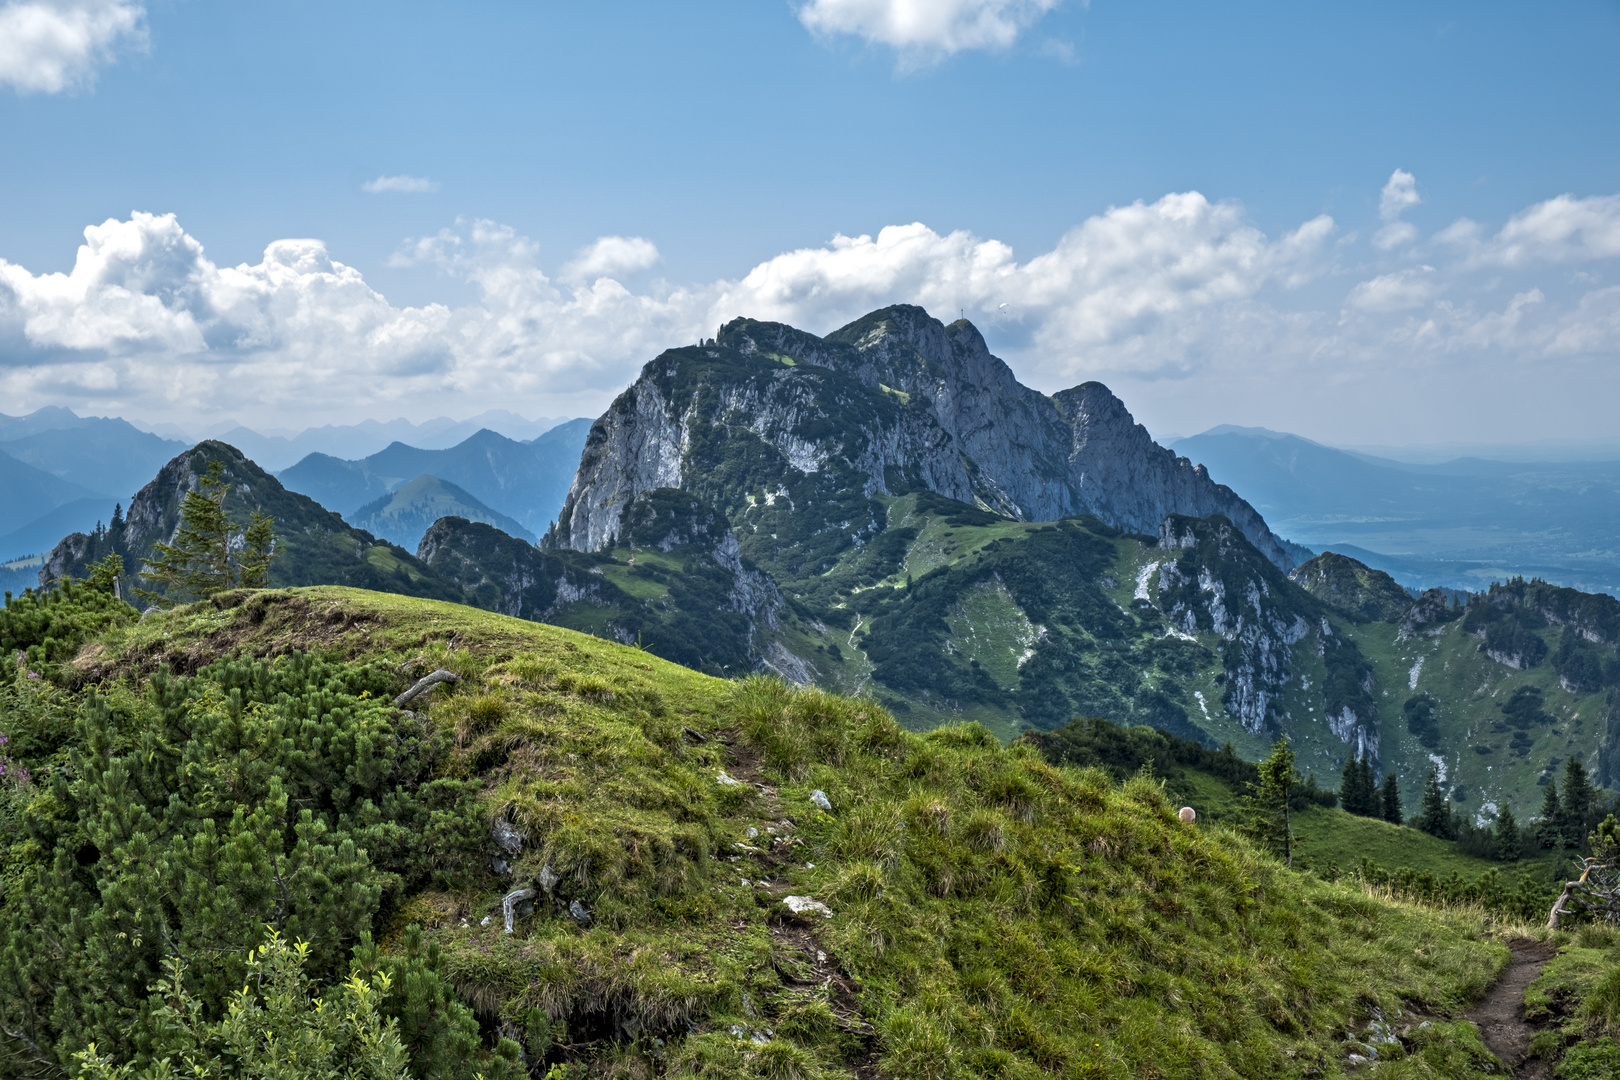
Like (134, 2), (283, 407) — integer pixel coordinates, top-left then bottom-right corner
(0, 0), (146, 94)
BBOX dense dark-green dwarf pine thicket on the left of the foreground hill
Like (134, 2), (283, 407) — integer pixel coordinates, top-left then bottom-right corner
(0, 654), (498, 1077)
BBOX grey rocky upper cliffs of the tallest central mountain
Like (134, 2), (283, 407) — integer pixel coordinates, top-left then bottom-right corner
(546, 306), (1293, 570)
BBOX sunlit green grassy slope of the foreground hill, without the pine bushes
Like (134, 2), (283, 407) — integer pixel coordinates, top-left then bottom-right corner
(22, 588), (1507, 1078)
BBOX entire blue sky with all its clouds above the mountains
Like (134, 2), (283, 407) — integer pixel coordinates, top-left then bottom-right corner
(0, 0), (1620, 444)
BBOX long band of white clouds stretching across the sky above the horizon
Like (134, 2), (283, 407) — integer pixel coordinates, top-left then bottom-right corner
(9, 179), (1620, 437)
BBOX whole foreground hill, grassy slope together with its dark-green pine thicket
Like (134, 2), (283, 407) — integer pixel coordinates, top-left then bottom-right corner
(0, 586), (1568, 1077)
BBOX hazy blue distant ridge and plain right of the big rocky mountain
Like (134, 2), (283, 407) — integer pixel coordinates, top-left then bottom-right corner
(1170, 426), (1620, 594)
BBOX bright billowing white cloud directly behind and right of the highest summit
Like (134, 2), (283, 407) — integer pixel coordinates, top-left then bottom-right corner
(710, 191), (1333, 377)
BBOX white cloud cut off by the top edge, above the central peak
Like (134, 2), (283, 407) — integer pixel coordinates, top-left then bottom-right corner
(799, 0), (1061, 62)
